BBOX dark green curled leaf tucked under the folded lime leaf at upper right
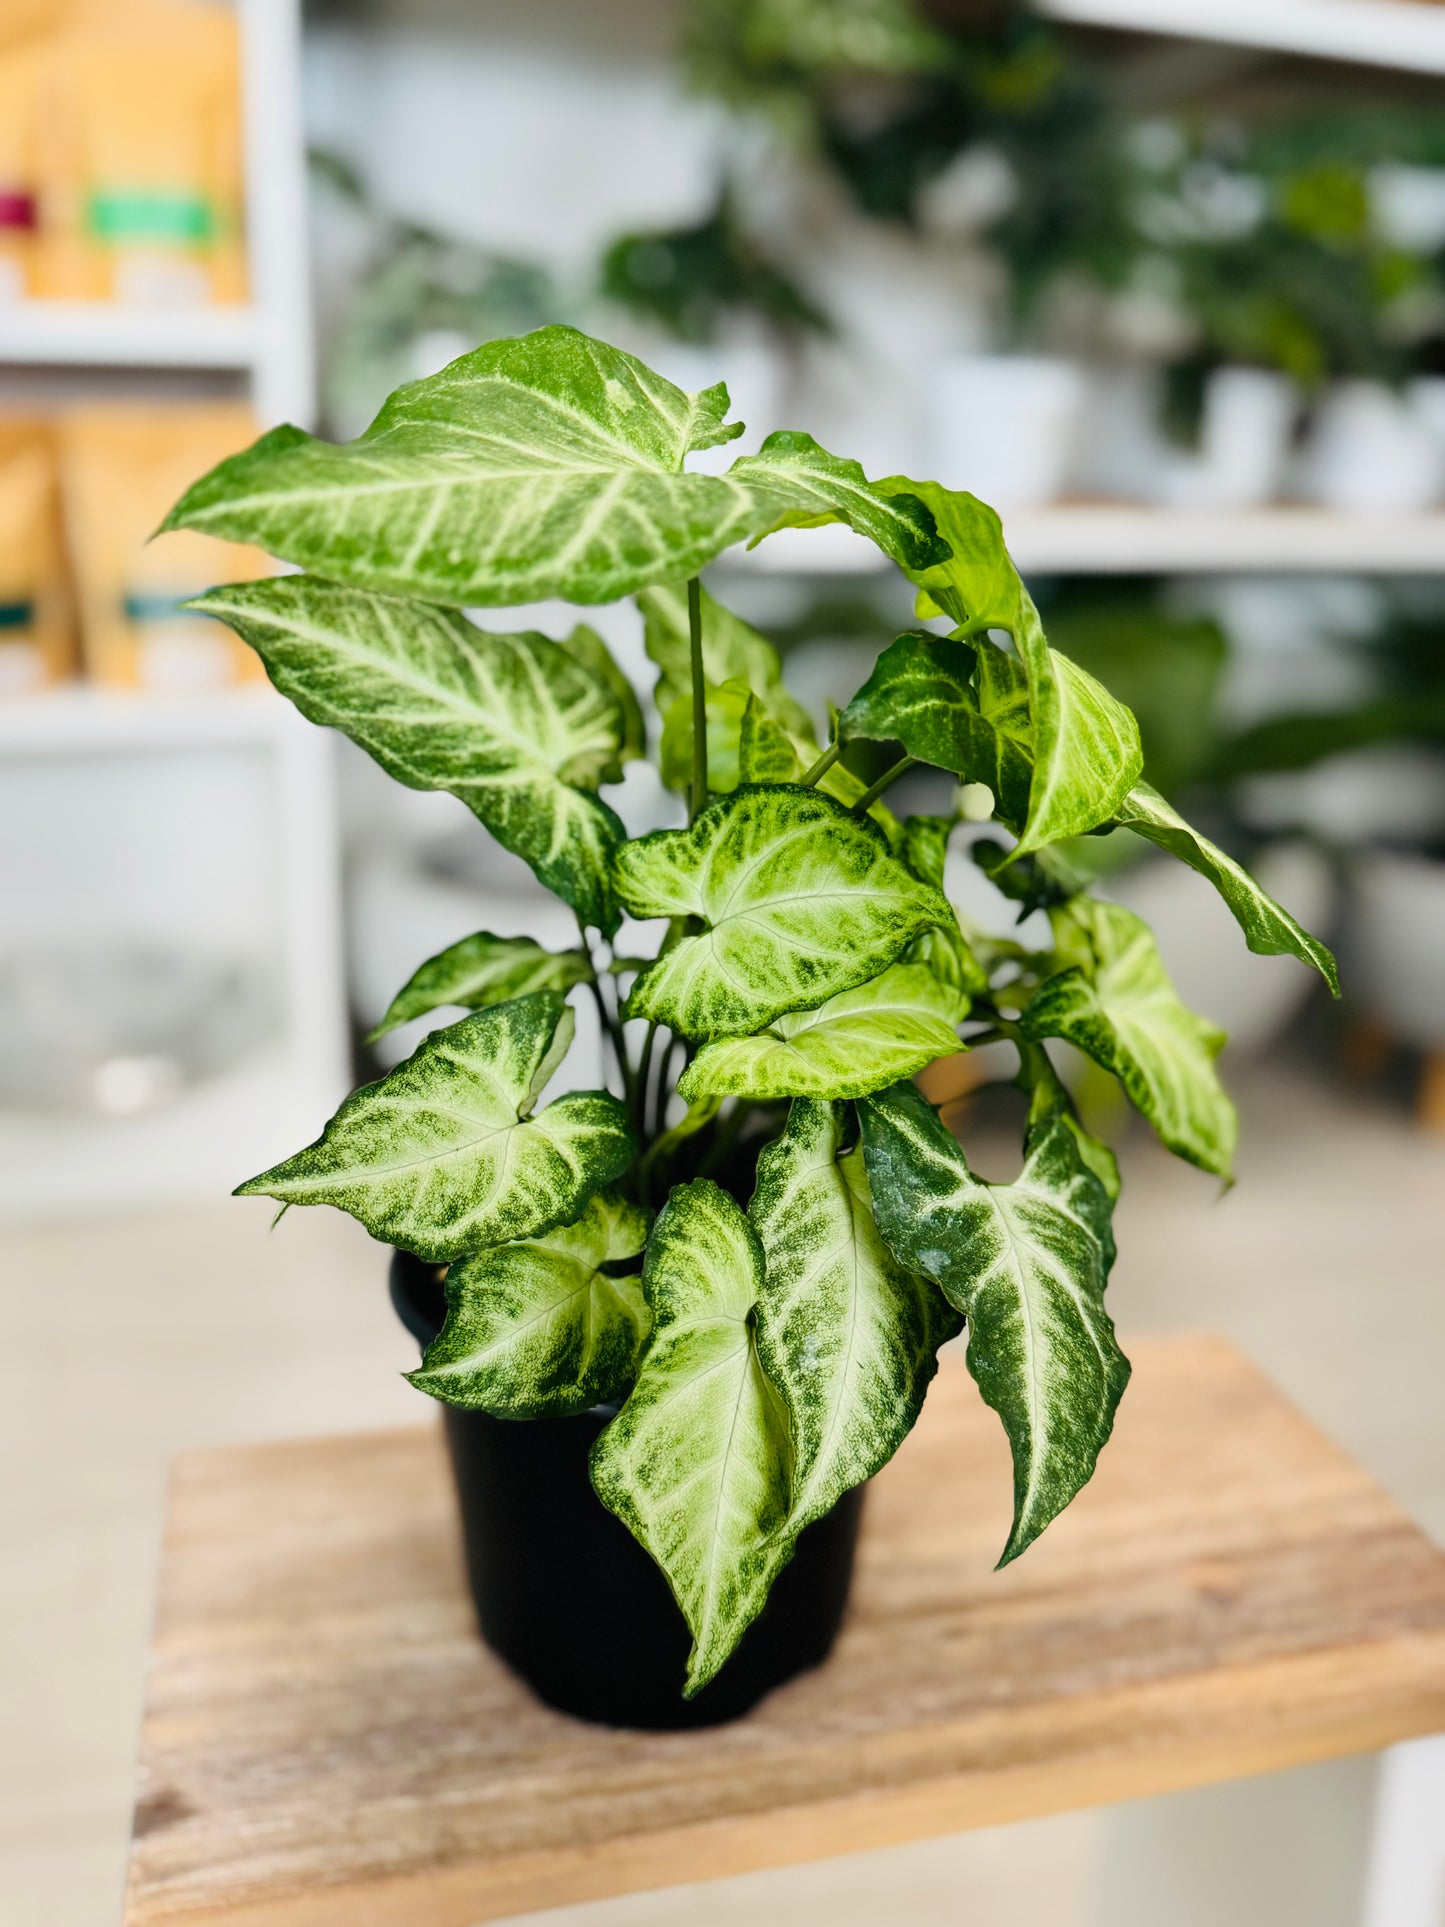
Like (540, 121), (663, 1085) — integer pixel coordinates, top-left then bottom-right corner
(838, 632), (1033, 831)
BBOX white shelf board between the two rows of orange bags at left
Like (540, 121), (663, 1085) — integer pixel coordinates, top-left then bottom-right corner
(0, 301), (258, 372)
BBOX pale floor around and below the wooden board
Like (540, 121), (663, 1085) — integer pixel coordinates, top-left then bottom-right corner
(0, 1071), (1445, 1927)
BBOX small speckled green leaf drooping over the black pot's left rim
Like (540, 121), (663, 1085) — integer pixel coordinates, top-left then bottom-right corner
(407, 1191), (651, 1418)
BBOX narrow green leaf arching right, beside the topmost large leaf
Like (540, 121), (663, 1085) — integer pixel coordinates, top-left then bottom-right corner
(728, 439), (948, 570)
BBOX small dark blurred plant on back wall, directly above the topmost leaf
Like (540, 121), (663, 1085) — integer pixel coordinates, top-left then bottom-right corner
(601, 189), (830, 343)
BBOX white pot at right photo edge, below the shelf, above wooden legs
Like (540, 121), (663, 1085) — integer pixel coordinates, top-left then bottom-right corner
(1345, 850), (1445, 1050)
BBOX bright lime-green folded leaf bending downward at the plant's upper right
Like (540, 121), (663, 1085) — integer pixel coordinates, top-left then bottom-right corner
(877, 476), (1144, 854)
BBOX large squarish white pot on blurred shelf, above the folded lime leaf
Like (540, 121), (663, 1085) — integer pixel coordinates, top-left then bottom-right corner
(931, 355), (1085, 513)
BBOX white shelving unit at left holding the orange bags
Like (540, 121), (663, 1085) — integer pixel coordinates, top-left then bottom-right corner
(0, 0), (341, 1220)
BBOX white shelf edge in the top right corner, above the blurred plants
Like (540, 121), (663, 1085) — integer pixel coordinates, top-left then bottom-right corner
(1040, 0), (1445, 73)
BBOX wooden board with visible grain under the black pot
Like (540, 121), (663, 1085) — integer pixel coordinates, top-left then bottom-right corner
(125, 1337), (1445, 1927)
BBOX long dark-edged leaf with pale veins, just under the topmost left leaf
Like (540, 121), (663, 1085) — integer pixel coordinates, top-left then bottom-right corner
(191, 576), (624, 935)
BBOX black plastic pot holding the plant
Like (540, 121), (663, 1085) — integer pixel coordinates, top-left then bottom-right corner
(391, 1251), (863, 1729)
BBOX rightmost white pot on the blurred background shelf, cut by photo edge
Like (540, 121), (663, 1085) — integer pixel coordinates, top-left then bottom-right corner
(1302, 382), (1445, 515)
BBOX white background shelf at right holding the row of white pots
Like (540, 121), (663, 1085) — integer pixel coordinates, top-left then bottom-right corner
(724, 503), (1445, 576)
